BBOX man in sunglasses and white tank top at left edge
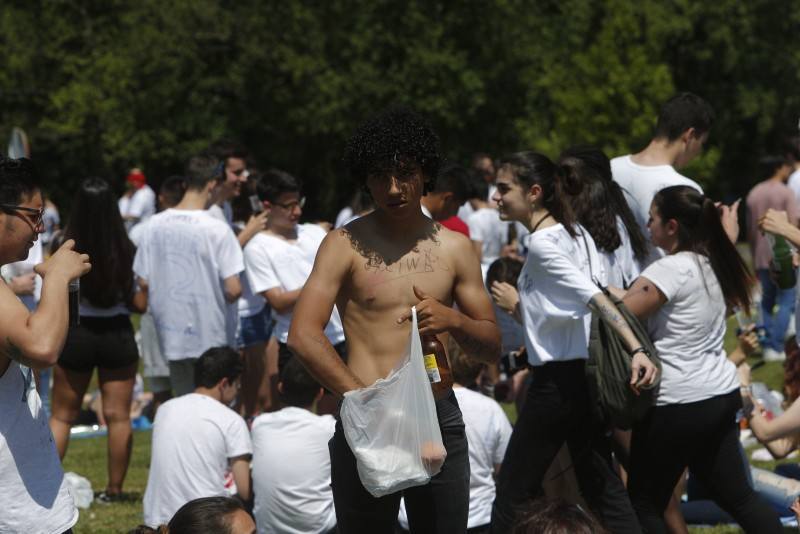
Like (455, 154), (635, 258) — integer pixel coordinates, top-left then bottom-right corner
(0, 157), (91, 533)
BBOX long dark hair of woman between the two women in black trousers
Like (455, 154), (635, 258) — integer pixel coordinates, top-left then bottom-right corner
(559, 145), (647, 261)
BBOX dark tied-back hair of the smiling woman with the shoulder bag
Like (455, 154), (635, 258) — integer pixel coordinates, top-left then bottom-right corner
(500, 152), (581, 237)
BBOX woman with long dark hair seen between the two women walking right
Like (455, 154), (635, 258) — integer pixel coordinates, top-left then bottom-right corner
(559, 145), (647, 289)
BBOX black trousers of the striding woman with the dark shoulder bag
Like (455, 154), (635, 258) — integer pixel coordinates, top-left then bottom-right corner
(492, 360), (641, 534)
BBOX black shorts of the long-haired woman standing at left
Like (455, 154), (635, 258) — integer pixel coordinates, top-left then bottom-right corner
(58, 315), (139, 372)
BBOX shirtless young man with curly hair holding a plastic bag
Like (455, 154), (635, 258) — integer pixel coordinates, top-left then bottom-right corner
(288, 110), (500, 534)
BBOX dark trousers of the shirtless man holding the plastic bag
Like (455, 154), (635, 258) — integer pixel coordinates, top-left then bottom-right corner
(329, 392), (469, 534)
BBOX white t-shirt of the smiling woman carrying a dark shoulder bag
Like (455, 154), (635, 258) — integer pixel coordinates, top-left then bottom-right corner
(517, 224), (606, 366)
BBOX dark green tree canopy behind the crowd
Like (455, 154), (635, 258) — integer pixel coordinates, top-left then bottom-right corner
(0, 0), (800, 217)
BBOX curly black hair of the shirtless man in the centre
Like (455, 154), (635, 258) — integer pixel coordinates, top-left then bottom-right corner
(344, 107), (442, 193)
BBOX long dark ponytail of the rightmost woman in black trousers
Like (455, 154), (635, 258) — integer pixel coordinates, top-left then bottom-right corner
(653, 185), (753, 310)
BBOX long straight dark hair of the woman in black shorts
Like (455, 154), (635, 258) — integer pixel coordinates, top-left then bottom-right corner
(64, 177), (136, 308)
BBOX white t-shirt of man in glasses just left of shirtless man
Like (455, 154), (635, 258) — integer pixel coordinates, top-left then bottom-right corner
(244, 224), (344, 345)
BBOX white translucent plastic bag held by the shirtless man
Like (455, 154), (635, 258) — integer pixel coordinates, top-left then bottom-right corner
(340, 308), (447, 497)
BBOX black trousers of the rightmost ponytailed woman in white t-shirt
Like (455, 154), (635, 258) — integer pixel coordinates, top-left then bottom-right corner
(628, 389), (783, 534)
